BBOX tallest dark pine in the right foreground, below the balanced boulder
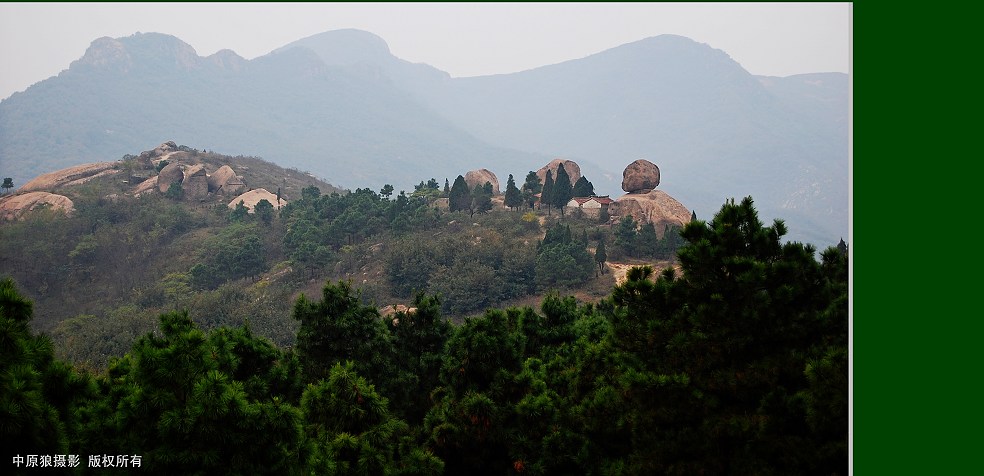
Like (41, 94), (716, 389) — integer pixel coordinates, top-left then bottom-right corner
(612, 198), (848, 474)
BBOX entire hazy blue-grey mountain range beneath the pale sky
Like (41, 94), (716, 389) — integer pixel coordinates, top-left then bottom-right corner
(0, 30), (849, 247)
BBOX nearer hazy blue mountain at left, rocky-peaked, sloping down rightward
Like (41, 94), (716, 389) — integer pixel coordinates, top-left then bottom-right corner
(0, 33), (545, 194)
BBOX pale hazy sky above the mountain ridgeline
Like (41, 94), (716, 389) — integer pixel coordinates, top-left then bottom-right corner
(0, 2), (852, 98)
